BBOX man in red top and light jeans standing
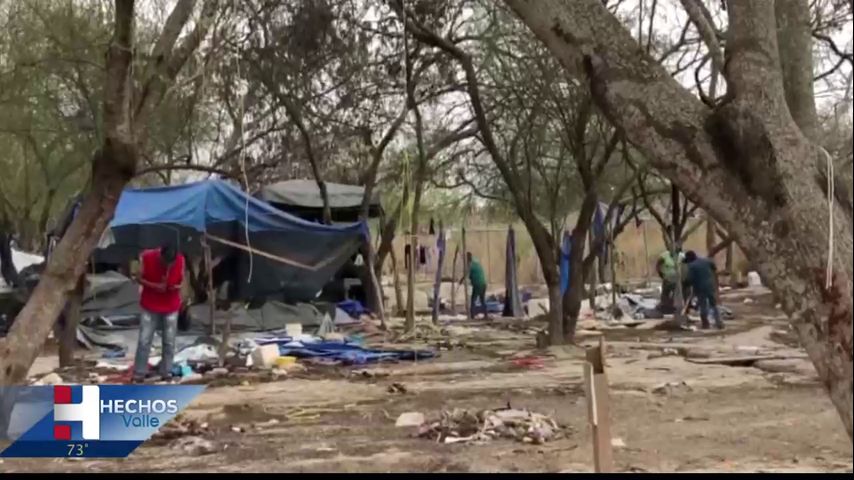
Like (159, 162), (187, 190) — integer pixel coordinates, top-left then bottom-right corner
(133, 243), (184, 382)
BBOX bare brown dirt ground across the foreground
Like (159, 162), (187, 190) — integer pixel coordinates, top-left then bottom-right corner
(0, 291), (852, 473)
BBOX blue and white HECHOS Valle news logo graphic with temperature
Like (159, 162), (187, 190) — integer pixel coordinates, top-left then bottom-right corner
(0, 385), (204, 458)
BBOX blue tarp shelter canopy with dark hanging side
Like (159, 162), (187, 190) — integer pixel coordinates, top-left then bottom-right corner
(95, 180), (369, 302)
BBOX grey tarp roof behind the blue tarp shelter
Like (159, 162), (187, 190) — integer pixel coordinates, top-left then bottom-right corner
(258, 180), (382, 222)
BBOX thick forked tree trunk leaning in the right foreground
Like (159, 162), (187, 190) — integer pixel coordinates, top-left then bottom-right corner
(505, 0), (854, 437)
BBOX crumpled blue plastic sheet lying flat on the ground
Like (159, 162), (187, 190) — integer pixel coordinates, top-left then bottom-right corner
(257, 337), (436, 365)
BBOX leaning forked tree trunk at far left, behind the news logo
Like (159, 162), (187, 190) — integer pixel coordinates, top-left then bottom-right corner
(0, 0), (214, 385)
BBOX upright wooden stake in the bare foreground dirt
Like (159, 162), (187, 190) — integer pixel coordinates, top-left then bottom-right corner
(584, 337), (614, 473)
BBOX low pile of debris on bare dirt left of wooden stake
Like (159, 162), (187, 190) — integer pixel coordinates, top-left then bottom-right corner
(418, 407), (571, 445)
